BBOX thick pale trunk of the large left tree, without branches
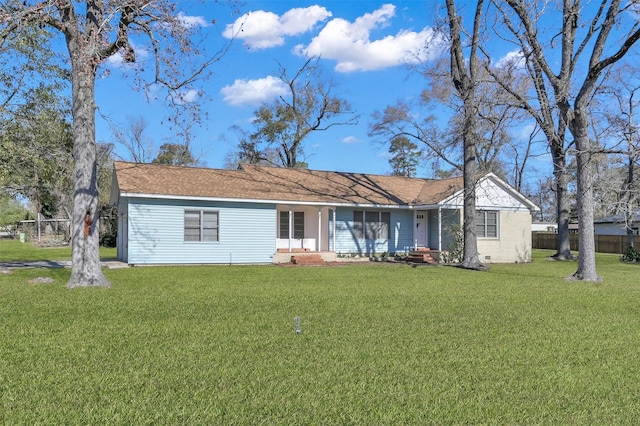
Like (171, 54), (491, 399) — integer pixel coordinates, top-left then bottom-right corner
(67, 43), (111, 288)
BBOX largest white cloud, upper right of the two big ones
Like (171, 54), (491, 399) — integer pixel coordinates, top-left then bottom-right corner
(295, 4), (442, 72)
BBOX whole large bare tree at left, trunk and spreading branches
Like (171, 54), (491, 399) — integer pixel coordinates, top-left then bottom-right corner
(0, 0), (232, 288)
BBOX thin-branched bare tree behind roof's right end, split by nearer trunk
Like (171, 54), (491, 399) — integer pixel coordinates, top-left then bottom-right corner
(369, 55), (533, 185)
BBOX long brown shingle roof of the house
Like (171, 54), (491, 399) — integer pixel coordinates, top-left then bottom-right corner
(115, 162), (462, 205)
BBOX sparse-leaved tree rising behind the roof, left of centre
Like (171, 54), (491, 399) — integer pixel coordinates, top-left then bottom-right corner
(238, 58), (358, 167)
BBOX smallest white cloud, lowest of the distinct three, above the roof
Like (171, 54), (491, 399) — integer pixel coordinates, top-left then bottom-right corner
(220, 76), (287, 106)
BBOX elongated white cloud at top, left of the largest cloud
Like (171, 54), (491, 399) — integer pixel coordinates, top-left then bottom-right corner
(222, 6), (331, 49)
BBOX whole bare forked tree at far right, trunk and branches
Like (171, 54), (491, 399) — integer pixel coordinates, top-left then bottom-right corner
(502, 0), (640, 281)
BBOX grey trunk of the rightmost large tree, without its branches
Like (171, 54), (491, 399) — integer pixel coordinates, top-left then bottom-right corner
(570, 108), (602, 281)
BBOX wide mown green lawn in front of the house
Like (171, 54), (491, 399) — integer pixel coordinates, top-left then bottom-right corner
(0, 243), (640, 425)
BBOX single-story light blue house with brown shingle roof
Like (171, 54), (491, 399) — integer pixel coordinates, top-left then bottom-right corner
(111, 162), (538, 264)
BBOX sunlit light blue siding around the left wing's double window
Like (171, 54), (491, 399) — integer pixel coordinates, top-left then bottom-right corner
(128, 199), (276, 264)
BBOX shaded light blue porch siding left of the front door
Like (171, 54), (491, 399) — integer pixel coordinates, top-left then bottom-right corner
(329, 208), (413, 255)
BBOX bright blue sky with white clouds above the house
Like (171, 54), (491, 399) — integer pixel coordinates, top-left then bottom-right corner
(96, 0), (536, 176)
